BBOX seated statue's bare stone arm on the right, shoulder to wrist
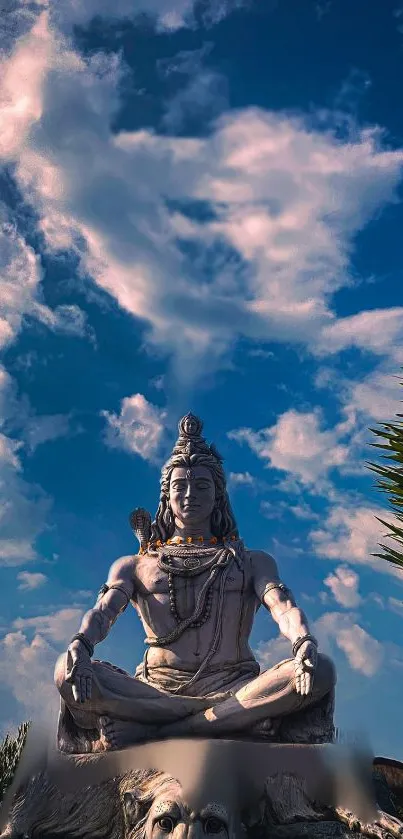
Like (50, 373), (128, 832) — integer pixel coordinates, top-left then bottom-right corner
(251, 551), (310, 644)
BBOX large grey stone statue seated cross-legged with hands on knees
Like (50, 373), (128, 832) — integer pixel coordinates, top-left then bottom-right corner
(55, 414), (336, 752)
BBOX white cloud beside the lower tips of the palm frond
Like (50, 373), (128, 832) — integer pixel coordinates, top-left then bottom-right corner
(310, 503), (401, 576)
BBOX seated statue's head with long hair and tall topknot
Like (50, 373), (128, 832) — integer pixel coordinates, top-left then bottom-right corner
(152, 414), (238, 542)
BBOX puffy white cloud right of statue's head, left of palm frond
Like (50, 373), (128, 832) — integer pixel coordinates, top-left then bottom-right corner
(228, 409), (350, 485)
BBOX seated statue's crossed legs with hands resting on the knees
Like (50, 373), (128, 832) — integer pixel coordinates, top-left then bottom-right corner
(55, 654), (336, 748)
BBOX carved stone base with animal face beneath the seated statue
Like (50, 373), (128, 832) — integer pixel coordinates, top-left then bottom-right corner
(0, 737), (403, 839)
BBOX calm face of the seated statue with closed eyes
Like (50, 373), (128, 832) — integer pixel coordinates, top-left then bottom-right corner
(169, 466), (215, 524)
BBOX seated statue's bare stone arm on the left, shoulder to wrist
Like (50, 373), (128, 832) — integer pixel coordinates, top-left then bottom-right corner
(75, 556), (135, 647)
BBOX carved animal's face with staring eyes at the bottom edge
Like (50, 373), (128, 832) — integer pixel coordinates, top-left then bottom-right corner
(145, 785), (229, 839)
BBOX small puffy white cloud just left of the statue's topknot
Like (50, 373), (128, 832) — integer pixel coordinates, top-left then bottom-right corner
(102, 393), (166, 461)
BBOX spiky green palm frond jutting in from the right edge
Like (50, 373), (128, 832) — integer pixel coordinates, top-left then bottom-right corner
(366, 382), (403, 568)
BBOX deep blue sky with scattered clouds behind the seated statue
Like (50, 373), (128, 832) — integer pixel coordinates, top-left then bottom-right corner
(0, 0), (403, 758)
